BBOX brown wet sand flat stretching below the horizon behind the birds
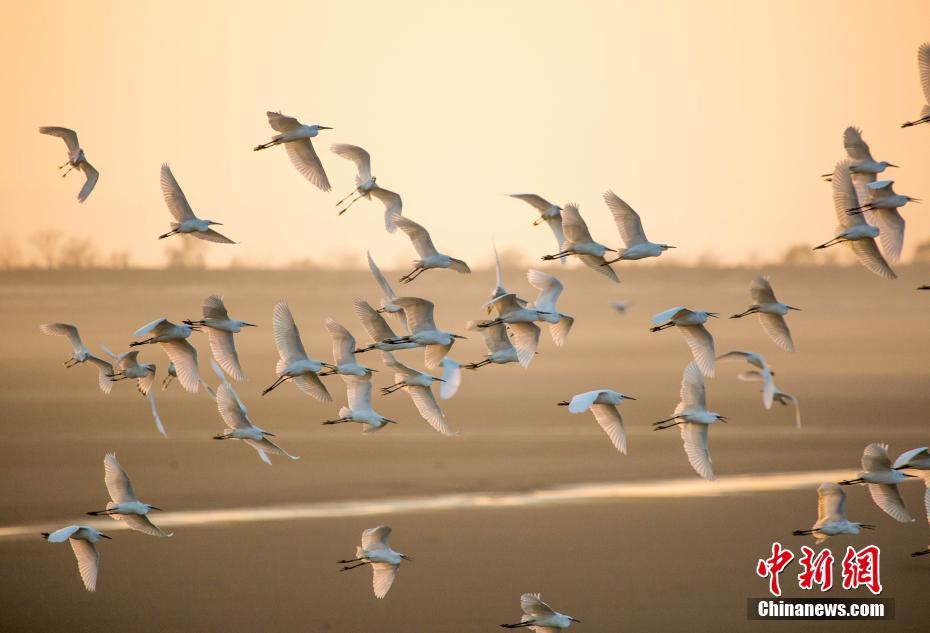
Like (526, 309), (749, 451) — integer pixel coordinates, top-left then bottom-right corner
(0, 267), (930, 632)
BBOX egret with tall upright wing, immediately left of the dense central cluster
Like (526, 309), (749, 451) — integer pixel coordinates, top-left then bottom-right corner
(262, 301), (335, 402)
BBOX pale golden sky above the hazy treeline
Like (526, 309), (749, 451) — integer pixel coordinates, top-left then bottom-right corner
(0, 0), (930, 265)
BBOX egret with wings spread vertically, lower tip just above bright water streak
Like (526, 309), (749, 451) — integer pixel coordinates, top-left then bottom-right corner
(653, 362), (727, 480)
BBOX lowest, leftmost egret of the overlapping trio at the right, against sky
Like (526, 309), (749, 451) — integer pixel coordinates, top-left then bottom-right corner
(814, 162), (897, 279)
